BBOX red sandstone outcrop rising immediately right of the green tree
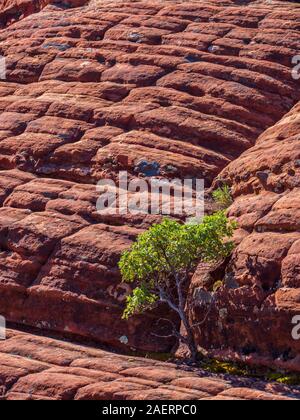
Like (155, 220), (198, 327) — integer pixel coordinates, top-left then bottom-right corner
(191, 106), (300, 372)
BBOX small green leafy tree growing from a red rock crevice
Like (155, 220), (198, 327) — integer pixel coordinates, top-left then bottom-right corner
(119, 211), (235, 359)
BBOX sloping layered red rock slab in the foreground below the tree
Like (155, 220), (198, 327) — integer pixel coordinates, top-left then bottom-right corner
(0, 330), (300, 400)
